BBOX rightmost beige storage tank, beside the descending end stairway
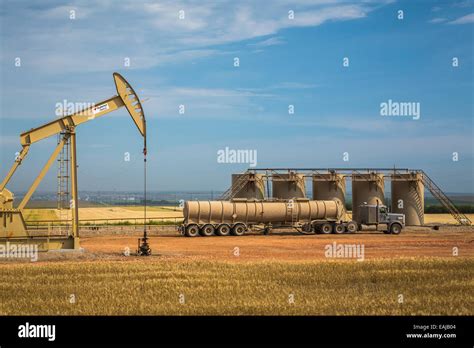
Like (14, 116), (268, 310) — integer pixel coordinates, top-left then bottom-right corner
(391, 172), (425, 226)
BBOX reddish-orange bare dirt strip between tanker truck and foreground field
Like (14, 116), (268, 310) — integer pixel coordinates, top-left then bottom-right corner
(75, 227), (474, 261)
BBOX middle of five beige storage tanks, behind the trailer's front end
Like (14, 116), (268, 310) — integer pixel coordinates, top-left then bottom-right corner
(313, 173), (346, 219)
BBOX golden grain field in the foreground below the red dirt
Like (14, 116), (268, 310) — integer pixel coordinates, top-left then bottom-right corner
(0, 257), (474, 315)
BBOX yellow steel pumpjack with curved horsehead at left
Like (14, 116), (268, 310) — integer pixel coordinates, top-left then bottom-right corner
(0, 73), (146, 250)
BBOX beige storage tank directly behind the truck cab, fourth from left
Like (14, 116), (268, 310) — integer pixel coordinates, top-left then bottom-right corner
(352, 173), (385, 220)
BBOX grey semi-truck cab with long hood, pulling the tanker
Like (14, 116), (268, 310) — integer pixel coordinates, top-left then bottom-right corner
(356, 204), (405, 234)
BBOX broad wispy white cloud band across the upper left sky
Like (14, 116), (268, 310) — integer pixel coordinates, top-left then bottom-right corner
(0, 0), (389, 74)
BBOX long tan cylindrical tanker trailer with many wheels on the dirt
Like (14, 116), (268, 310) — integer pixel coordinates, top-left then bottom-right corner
(179, 198), (357, 237)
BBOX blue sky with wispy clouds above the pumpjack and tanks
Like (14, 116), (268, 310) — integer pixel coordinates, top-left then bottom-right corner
(0, 0), (474, 192)
